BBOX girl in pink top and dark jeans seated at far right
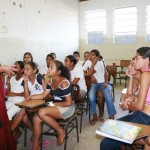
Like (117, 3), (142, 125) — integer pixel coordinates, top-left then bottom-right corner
(100, 47), (150, 150)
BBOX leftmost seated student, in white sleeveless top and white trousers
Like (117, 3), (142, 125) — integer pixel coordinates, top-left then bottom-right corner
(5, 61), (24, 121)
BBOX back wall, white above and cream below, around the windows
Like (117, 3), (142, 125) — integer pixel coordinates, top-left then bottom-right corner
(79, 0), (150, 64)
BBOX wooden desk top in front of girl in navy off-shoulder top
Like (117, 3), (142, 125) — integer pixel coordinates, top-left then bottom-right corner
(15, 99), (45, 109)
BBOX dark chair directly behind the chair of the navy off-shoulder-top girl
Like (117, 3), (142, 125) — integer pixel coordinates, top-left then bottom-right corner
(72, 84), (88, 133)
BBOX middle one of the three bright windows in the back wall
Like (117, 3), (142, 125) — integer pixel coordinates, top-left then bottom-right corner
(114, 7), (137, 43)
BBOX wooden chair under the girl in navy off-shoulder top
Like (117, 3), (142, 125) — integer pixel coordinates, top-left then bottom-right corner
(41, 112), (79, 150)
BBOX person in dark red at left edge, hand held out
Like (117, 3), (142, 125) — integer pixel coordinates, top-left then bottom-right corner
(0, 66), (16, 150)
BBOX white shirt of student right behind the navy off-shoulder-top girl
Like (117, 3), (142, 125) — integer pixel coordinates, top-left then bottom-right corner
(70, 66), (87, 91)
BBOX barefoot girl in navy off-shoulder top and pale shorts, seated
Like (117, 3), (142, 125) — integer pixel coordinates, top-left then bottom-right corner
(31, 60), (75, 150)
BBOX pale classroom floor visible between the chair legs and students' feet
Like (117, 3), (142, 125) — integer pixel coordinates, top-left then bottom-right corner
(17, 84), (128, 150)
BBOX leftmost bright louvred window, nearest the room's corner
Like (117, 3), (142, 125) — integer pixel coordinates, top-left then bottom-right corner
(85, 10), (106, 44)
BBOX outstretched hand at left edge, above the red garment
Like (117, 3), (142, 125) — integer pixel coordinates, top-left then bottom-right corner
(0, 65), (17, 77)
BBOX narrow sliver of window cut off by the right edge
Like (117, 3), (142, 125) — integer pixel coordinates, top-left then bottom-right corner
(146, 5), (150, 42)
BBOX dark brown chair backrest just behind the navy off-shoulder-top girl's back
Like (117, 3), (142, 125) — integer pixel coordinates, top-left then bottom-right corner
(71, 84), (80, 101)
